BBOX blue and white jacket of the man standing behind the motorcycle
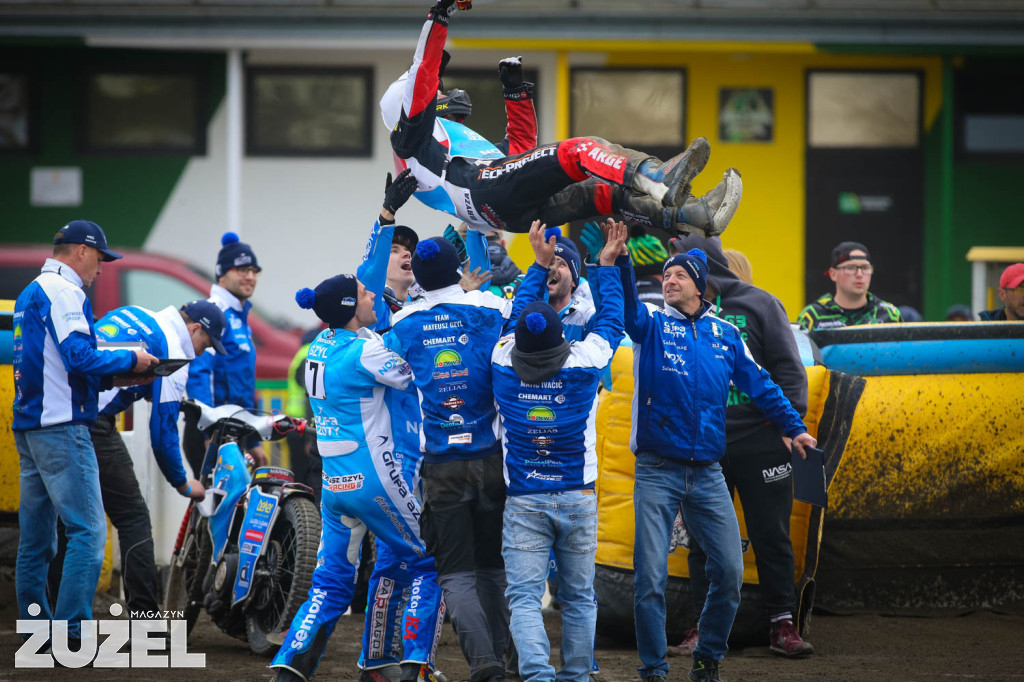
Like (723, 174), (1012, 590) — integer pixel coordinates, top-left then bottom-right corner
(186, 285), (256, 409)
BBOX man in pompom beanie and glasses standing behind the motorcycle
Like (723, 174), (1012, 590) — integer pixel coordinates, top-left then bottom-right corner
(185, 228), (267, 472)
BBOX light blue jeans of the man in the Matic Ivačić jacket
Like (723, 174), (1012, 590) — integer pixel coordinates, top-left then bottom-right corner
(502, 491), (597, 682)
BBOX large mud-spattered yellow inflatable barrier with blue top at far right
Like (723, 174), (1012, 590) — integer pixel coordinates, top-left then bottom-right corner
(812, 323), (1024, 610)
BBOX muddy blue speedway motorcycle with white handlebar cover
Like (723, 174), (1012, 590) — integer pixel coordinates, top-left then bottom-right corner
(165, 400), (321, 655)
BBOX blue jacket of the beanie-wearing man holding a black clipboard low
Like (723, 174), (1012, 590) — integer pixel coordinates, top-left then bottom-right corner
(622, 258), (807, 463)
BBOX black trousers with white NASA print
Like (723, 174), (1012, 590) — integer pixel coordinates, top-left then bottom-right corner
(689, 426), (797, 617)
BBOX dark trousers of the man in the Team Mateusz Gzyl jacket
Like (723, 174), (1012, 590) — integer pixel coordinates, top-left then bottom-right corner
(420, 452), (509, 682)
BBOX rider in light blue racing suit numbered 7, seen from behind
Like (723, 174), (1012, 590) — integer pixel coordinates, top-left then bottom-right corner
(270, 274), (443, 680)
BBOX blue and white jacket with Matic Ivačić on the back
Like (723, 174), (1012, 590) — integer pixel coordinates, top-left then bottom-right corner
(490, 266), (624, 495)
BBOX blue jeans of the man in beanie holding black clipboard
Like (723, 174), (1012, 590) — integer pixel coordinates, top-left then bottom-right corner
(633, 452), (743, 677)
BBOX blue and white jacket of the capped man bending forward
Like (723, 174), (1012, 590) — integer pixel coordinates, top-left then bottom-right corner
(96, 305), (196, 488)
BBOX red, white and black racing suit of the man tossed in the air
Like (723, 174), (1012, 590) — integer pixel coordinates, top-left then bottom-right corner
(380, 3), (674, 232)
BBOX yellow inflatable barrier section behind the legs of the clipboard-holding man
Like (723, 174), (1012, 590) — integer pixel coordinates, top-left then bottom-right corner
(594, 346), (864, 646)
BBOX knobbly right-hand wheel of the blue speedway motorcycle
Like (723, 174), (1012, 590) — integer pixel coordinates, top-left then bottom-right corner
(246, 496), (321, 655)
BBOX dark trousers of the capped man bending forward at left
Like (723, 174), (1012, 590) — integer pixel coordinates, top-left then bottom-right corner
(92, 416), (159, 614)
